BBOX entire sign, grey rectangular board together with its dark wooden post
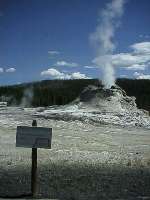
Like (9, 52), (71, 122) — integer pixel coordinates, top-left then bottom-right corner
(16, 120), (52, 198)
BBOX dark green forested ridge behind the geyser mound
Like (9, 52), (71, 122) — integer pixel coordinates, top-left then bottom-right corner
(0, 79), (150, 111)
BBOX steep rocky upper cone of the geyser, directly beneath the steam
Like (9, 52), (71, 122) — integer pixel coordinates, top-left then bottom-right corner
(76, 85), (137, 112)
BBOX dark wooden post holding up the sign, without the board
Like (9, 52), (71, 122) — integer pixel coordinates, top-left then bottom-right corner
(31, 120), (37, 198)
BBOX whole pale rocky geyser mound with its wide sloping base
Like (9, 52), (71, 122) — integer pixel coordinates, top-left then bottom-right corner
(35, 85), (150, 127)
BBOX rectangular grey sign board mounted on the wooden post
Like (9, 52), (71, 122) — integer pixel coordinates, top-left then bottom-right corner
(16, 126), (52, 149)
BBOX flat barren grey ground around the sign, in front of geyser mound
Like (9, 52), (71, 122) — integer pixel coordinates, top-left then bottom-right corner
(0, 108), (150, 200)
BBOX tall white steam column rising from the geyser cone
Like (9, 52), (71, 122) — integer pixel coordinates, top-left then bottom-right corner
(91, 0), (125, 88)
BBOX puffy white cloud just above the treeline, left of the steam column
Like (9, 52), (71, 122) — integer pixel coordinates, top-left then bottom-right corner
(41, 68), (89, 79)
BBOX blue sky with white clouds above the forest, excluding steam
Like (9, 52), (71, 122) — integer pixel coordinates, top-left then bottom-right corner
(0, 0), (150, 85)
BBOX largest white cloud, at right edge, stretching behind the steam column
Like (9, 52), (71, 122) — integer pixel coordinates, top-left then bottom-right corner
(93, 42), (150, 70)
